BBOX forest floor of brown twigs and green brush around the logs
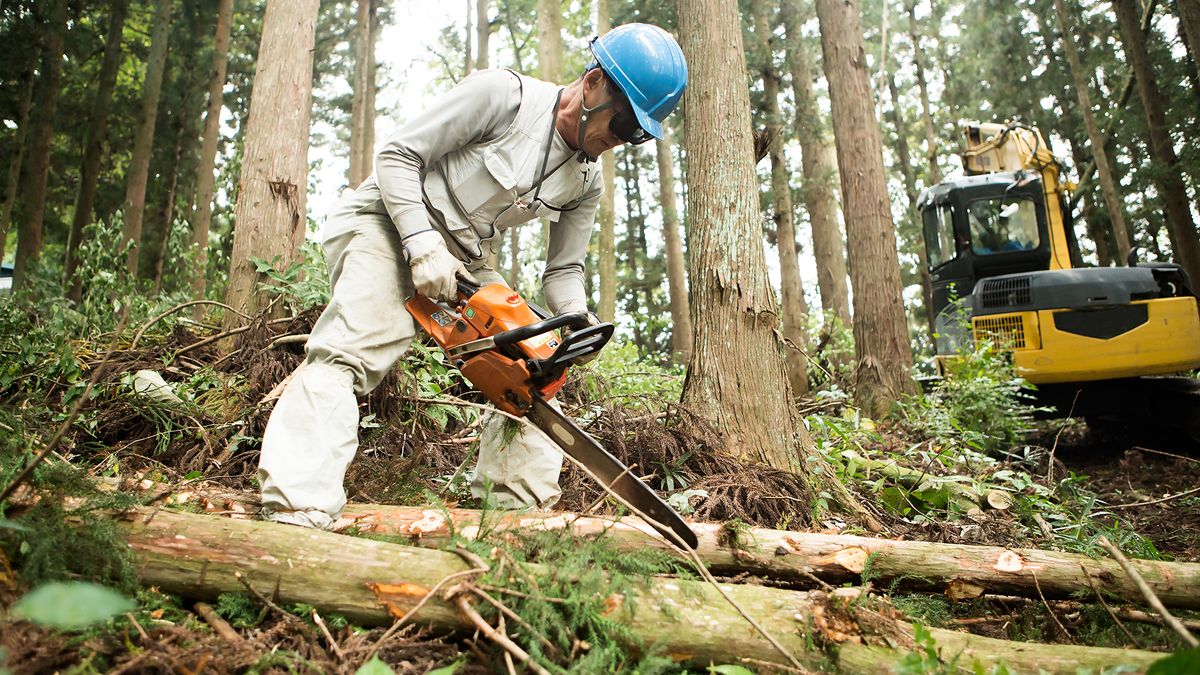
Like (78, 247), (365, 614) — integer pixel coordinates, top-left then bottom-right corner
(0, 302), (1200, 674)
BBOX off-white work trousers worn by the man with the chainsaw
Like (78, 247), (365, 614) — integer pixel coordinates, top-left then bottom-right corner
(258, 195), (563, 528)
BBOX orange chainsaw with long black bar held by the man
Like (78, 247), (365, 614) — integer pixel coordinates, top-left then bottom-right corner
(404, 280), (697, 549)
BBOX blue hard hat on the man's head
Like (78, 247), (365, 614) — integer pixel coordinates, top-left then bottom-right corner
(592, 24), (688, 138)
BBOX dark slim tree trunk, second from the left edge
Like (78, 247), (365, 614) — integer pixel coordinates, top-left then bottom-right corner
(62, 0), (128, 303)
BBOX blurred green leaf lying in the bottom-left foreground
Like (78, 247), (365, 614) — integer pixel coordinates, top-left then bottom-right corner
(12, 581), (136, 631)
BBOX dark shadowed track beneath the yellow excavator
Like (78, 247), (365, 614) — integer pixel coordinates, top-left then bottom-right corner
(1033, 377), (1200, 443)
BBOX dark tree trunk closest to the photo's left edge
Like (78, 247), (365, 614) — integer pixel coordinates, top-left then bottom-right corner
(12, 0), (67, 291)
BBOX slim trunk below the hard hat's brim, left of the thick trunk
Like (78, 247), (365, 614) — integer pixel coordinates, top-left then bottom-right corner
(657, 127), (691, 364)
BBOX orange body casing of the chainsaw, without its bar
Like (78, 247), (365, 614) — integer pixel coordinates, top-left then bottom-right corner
(404, 283), (566, 416)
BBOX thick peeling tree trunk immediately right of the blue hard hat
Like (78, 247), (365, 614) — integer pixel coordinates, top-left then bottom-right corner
(678, 0), (812, 468)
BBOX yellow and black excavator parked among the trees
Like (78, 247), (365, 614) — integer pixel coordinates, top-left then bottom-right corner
(918, 121), (1200, 440)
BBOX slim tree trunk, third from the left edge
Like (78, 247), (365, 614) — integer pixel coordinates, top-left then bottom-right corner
(124, 0), (174, 276)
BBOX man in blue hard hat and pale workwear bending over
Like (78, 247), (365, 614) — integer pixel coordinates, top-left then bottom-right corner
(259, 24), (688, 528)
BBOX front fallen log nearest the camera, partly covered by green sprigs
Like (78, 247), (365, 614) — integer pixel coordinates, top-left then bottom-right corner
(114, 508), (1163, 673)
